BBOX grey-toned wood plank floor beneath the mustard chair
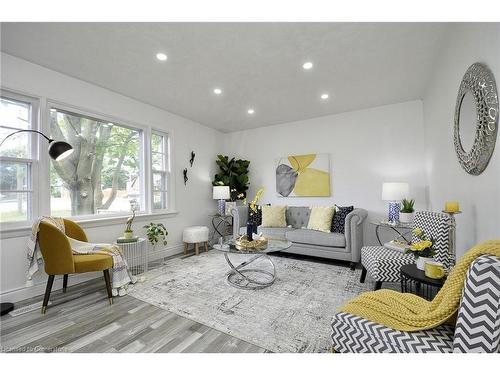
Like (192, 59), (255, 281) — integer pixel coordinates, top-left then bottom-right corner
(0, 258), (265, 353)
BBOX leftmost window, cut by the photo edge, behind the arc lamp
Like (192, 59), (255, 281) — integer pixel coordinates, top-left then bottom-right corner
(0, 91), (38, 223)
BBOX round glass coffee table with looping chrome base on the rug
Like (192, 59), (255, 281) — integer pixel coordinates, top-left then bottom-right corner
(213, 236), (292, 290)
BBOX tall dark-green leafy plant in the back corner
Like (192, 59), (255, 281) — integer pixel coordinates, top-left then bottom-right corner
(212, 155), (250, 201)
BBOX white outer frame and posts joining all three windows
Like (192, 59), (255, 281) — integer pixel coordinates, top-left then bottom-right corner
(0, 90), (179, 232)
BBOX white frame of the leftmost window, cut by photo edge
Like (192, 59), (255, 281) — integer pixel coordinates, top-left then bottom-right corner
(0, 87), (39, 231)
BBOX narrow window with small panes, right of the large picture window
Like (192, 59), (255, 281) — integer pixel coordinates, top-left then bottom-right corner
(151, 131), (170, 211)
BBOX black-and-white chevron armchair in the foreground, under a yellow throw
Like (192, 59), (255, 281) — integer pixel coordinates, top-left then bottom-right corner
(331, 255), (500, 353)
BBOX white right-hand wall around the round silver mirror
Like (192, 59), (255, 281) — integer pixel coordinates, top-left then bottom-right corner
(423, 24), (500, 255)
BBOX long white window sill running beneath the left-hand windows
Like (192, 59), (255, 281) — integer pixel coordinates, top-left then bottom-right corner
(0, 211), (179, 240)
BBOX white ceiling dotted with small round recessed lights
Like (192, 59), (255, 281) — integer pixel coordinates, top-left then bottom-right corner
(1, 23), (447, 132)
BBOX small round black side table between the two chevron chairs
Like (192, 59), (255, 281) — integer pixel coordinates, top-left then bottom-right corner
(400, 264), (446, 301)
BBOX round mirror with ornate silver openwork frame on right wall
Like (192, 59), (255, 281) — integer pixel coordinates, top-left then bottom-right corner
(453, 63), (498, 175)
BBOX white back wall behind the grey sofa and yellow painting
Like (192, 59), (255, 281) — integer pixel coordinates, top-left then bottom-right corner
(225, 98), (427, 244)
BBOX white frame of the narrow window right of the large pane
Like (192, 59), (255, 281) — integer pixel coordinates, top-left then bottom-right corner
(149, 128), (172, 213)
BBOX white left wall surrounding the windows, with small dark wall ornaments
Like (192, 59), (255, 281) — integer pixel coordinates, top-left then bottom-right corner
(0, 54), (221, 301)
